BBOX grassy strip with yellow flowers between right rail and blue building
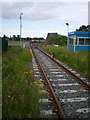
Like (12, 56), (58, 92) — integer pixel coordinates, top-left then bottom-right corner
(42, 45), (90, 79)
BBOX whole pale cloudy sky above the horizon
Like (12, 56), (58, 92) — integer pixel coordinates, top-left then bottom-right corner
(0, 0), (89, 38)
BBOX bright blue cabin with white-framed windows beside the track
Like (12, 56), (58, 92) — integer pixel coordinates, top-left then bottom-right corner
(67, 31), (90, 51)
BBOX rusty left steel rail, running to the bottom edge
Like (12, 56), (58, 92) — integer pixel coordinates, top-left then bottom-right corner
(31, 44), (67, 120)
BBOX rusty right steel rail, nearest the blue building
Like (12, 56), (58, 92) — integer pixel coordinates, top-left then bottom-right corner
(35, 46), (90, 91)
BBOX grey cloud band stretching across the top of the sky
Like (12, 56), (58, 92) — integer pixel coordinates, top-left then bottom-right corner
(2, 2), (88, 21)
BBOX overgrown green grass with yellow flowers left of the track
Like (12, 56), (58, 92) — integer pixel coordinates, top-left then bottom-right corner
(2, 46), (40, 119)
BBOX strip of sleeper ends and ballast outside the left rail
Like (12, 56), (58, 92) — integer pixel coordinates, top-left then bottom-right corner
(32, 56), (58, 120)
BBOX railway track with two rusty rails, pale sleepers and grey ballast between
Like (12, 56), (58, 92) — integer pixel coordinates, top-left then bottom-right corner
(31, 44), (90, 120)
